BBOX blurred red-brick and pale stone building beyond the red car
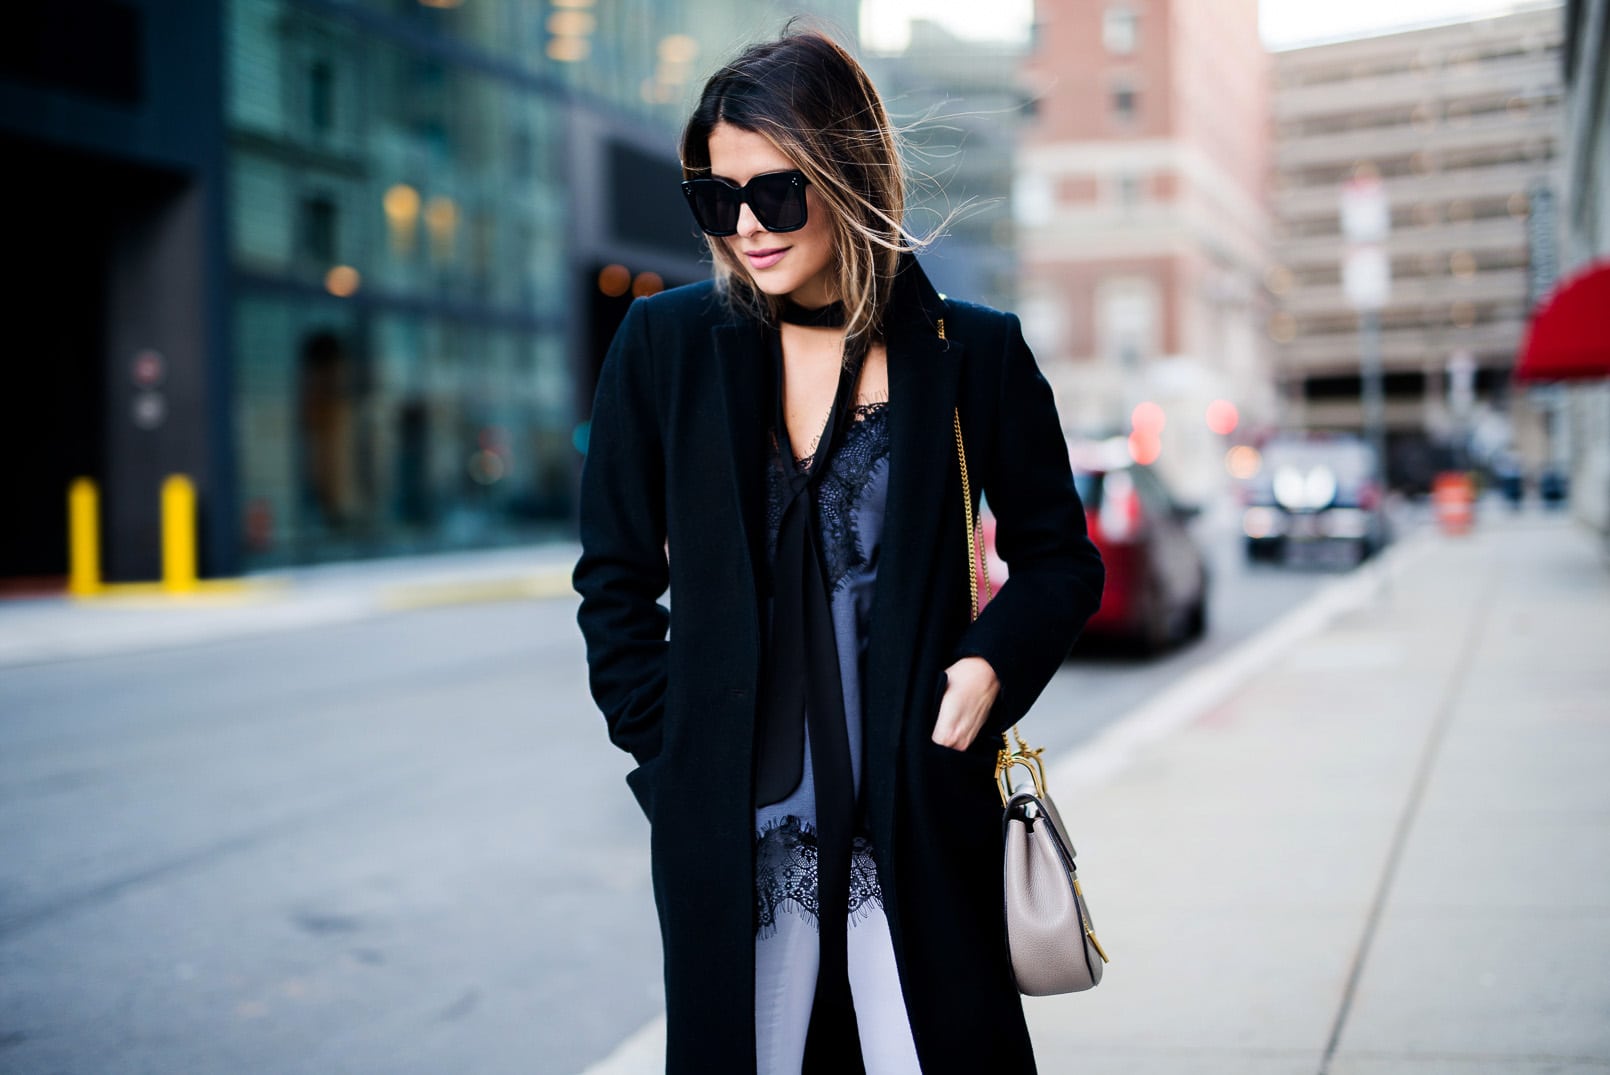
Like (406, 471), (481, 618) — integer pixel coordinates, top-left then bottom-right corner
(1014, 0), (1272, 496)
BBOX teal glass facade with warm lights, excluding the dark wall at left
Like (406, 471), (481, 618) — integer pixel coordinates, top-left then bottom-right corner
(225, 0), (855, 566)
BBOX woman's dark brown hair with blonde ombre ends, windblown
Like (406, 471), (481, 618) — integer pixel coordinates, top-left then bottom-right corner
(681, 26), (926, 352)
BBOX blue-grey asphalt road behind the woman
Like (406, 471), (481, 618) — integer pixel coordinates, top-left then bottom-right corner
(0, 514), (1327, 1075)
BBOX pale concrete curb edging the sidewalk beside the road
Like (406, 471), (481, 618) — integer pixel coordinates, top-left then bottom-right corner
(581, 534), (1430, 1075)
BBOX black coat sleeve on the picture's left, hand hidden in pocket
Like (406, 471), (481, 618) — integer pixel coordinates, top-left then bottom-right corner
(572, 299), (671, 764)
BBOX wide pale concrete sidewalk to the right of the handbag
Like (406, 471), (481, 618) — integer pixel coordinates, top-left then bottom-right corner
(1029, 515), (1610, 1075)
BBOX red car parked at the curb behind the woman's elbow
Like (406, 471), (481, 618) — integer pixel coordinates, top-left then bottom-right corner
(984, 446), (1208, 653)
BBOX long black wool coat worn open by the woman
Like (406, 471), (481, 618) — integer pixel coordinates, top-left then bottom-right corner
(575, 257), (1103, 1075)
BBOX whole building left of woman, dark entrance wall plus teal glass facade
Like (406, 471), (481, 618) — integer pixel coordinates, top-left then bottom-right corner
(0, 0), (860, 589)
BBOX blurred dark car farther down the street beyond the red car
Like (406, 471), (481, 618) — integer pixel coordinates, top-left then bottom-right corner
(1241, 435), (1388, 563)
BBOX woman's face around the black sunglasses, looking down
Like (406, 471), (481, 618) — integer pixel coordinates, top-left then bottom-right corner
(710, 122), (837, 307)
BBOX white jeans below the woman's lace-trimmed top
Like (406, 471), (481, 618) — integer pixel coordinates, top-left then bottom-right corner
(755, 903), (923, 1075)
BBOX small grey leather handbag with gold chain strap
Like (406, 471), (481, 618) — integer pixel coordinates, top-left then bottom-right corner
(939, 378), (1108, 996)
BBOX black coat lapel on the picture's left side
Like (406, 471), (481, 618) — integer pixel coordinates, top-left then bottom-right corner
(713, 320), (776, 624)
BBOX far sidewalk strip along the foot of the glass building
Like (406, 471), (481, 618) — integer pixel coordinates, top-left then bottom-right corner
(0, 542), (580, 668)
